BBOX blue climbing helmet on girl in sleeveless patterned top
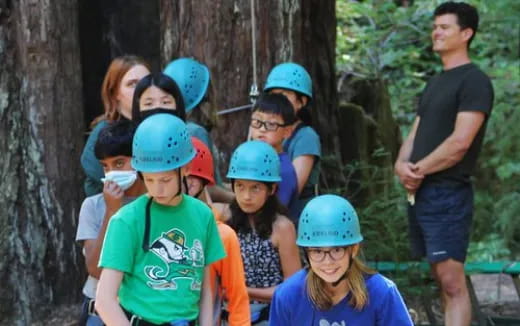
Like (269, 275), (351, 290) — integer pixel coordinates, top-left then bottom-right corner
(227, 140), (282, 182)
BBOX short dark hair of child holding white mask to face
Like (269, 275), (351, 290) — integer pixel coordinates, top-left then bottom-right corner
(94, 119), (135, 160)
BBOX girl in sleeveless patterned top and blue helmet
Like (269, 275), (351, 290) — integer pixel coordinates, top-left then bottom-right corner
(227, 140), (301, 322)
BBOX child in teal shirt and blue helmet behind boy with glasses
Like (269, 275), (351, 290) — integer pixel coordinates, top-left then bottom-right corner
(264, 62), (321, 222)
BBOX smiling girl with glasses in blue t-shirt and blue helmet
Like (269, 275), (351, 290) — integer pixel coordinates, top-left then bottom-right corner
(269, 195), (413, 326)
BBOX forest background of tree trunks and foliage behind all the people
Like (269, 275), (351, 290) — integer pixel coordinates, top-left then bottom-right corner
(0, 0), (520, 325)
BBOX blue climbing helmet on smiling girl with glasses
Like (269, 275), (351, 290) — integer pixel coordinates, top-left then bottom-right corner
(296, 195), (363, 247)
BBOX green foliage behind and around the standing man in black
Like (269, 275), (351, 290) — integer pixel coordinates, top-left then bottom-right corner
(336, 0), (520, 260)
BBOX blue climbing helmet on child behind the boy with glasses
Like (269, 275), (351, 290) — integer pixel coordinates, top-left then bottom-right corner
(264, 62), (312, 99)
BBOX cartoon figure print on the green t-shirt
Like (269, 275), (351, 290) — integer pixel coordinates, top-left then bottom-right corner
(144, 228), (204, 290)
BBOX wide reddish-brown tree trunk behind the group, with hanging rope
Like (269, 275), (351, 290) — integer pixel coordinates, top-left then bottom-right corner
(160, 0), (339, 175)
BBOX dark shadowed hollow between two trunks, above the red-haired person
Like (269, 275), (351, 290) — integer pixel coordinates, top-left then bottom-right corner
(79, 0), (161, 123)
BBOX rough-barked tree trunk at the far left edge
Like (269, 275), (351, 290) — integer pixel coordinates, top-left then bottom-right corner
(0, 0), (84, 325)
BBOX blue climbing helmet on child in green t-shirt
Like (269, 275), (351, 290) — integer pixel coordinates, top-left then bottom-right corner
(131, 113), (195, 172)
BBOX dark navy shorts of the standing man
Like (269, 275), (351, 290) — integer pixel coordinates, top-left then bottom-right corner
(408, 183), (473, 263)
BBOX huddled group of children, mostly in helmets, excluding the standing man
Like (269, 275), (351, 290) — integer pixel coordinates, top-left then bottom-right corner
(76, 56), (412, 326)
